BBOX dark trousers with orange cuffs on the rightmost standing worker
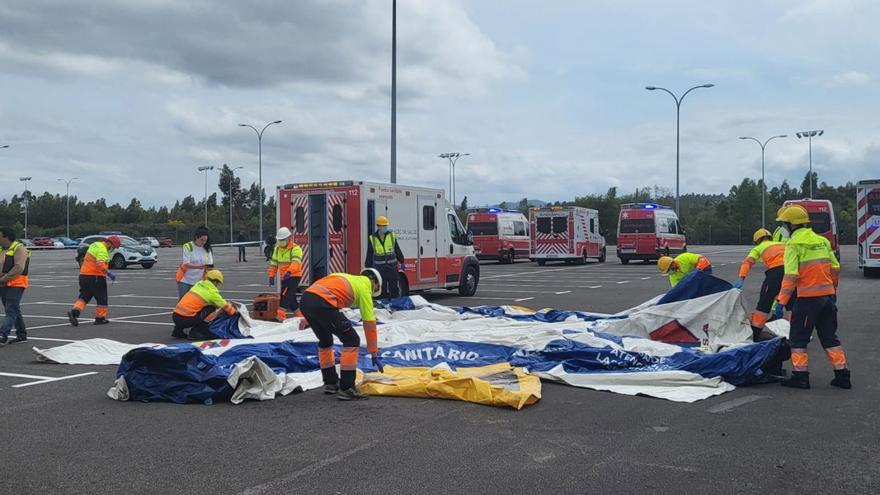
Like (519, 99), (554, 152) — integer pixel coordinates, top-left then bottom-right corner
(788, 296), (846, 371)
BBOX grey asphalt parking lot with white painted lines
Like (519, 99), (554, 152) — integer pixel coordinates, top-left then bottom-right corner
(0, 246), (880, 494)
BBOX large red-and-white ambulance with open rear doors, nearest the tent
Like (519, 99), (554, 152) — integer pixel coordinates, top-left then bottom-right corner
(275, 180), (480, 296)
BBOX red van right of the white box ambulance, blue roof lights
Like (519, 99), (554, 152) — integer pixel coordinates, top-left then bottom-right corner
(617, 203), (687, 265)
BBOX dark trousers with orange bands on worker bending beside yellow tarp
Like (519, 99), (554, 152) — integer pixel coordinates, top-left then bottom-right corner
(300, 292), (361, 390)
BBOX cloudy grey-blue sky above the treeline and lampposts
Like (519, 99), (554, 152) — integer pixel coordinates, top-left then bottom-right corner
(0, 0), (880, 205)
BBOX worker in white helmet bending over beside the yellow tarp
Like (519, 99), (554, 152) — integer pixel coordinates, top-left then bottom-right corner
(300, 268), (382, 400)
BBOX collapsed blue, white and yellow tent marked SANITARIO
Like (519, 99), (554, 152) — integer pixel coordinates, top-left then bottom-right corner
(34, 272), (787, 409)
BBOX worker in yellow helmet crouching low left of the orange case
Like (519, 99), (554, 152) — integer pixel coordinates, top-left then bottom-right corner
(171, 270), (237, 340)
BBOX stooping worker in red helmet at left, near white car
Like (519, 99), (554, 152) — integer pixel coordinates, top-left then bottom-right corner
(67, 235), (122, 326)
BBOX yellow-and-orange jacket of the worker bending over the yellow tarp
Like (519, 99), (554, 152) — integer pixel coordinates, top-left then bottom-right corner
(306, 273), (379, 353)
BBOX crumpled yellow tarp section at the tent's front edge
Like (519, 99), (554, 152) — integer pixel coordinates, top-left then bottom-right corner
(358, 363), (541, 409)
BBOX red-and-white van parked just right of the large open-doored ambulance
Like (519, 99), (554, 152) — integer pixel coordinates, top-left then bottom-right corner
(467, 208), (529, 263)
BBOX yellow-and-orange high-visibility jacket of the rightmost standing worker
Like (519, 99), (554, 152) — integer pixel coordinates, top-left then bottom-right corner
(776, 227), (840, 304)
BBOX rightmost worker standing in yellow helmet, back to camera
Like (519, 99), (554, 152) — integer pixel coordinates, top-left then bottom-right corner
(776, 206), (852, 389)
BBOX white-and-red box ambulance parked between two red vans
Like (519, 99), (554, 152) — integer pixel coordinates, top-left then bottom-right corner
(529, 206), (605, 266)
